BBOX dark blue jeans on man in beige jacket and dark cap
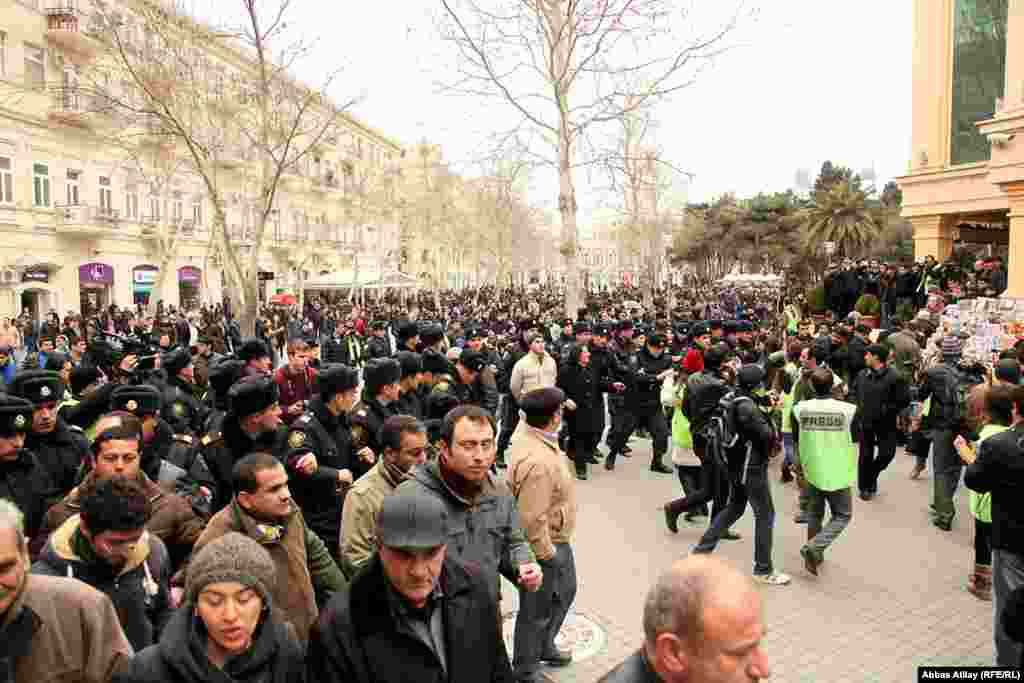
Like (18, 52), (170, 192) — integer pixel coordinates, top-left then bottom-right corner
(512, 543), (577, 681)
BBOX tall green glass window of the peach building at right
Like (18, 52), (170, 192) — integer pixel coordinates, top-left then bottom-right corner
(950, 0), (1008, 165)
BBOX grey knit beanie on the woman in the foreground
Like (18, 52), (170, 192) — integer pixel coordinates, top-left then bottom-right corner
(185, 531), (276, 608)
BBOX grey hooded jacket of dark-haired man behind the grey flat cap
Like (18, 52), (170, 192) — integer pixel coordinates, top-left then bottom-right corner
(398, 462), (535, 599)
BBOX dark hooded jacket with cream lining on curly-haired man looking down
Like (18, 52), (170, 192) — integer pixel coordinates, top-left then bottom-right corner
(32, 515), (172, 650)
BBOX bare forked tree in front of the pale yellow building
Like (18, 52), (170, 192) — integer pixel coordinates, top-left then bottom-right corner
(72, 0), (353, 332)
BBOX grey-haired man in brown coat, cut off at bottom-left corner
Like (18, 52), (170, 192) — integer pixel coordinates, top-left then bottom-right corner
(0, 500), (132, 683)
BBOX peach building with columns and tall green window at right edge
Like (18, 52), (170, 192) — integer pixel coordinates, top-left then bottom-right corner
(897, 0), (1024, 297)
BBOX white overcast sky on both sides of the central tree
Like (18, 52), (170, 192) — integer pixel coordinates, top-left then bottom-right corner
(207, 0), (913, 223)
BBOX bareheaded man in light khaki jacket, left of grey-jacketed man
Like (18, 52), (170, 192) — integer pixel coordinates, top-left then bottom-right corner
(339, 415), (427, 579)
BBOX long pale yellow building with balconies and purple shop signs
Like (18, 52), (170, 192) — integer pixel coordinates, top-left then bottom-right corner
(0, 0), (403, 323)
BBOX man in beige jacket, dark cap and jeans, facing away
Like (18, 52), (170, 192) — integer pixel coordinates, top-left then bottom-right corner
(508, 387), (577, 682)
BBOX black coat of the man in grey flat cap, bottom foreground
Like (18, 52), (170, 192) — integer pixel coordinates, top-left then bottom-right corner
(306, 556), (513, 683)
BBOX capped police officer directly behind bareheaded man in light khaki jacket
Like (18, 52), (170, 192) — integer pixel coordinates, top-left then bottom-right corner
(349, 358), (401, 478)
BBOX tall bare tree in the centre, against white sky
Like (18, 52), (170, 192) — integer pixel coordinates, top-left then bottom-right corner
(441, 0), (740, 314)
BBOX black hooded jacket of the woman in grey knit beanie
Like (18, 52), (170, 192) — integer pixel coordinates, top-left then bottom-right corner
(114, 603), (306, 683)
